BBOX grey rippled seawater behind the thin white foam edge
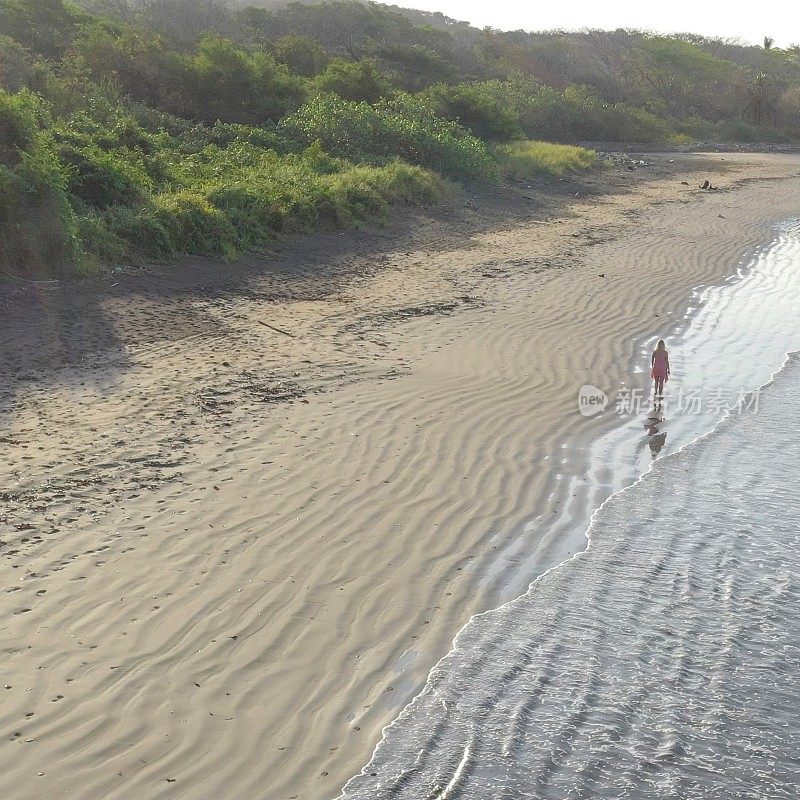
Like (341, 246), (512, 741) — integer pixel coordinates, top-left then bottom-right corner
(344, 358), (800, 800)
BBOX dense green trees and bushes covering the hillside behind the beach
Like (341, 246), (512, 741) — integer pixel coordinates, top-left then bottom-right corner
(0, 0), (800, 274)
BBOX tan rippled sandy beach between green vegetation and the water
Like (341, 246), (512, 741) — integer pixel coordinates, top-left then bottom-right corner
(0, 153), (800, 800)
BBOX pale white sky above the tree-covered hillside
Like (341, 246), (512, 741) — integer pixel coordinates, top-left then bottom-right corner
(376, 0), (800, 47)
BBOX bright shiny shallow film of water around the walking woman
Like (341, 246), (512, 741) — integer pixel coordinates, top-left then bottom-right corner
(492, 219), (800, 602)
